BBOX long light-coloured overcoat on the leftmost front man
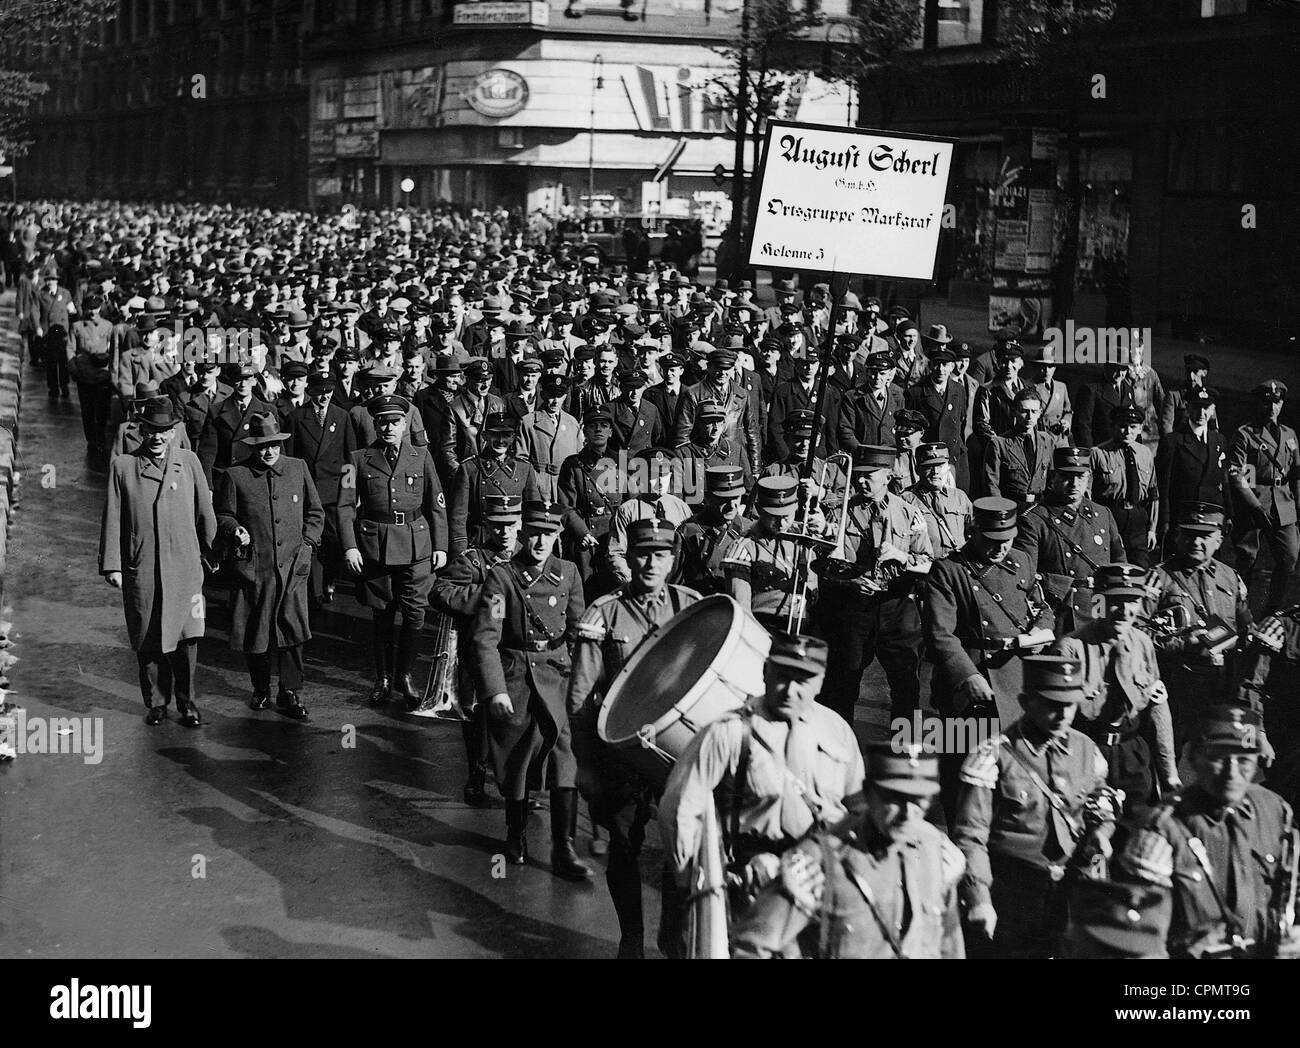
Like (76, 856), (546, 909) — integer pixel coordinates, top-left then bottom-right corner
(99, 445), (217, 653)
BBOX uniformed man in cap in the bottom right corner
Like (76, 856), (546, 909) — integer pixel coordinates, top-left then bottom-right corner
(1117, 706), (1295, 957)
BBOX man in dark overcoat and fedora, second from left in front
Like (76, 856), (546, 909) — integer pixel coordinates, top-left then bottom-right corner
(213, 413), (325, 720)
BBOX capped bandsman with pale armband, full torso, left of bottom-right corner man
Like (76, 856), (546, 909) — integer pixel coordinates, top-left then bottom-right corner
(953, 655), (1118, 958)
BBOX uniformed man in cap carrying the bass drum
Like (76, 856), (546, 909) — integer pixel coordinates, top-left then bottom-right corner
(568, 520), (699, 958)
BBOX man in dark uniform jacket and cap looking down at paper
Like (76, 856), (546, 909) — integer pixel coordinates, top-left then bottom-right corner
(922, 498), (1053, 819)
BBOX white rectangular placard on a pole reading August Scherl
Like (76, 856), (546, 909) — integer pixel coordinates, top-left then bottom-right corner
(749, 121), (953, 280)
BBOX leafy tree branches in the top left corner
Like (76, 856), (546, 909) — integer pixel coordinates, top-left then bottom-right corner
(0, 0), (117, 156)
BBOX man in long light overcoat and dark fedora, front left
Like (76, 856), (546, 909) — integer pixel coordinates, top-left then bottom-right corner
(99, 397), (217, 727)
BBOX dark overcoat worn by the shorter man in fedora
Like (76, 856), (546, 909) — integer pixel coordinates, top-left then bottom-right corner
(215, 455), (325, 654)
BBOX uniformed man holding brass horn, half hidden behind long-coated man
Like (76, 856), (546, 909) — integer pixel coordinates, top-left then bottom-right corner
(429, 495), (524, 807)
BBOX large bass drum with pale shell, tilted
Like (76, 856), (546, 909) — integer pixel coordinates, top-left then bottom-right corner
(597, 594), (772, 787)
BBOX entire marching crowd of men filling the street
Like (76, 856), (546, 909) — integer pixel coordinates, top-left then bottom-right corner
(7, 203), (1300, 957)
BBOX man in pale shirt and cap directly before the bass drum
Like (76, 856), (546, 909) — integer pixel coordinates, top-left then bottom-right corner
(659, 633), (865, 956)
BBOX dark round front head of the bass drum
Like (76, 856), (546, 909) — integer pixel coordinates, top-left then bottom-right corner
(602, 597), (736, 742)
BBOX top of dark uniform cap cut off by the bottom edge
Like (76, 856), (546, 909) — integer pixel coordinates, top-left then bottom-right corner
(1066, 878), (1174, 958)
